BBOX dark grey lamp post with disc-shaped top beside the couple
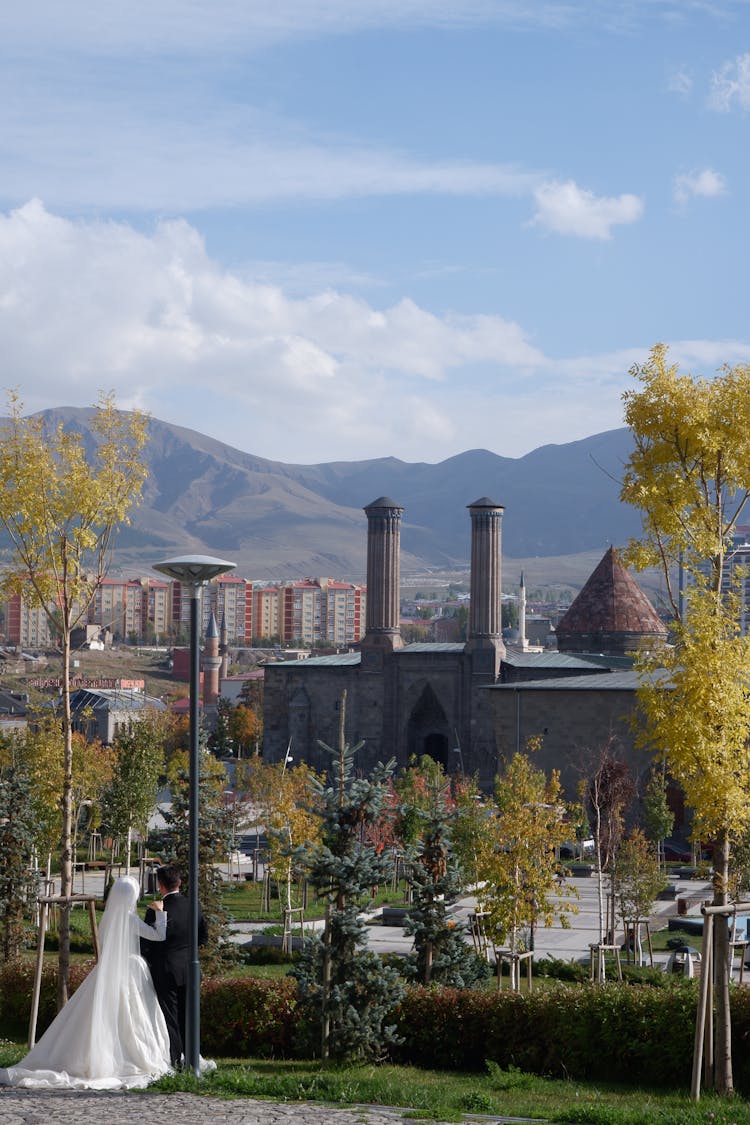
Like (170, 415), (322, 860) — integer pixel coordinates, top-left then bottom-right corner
(154, 555), (235, 1076)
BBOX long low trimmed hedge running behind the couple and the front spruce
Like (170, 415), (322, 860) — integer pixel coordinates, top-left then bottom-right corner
(0, 961), (750, 1094)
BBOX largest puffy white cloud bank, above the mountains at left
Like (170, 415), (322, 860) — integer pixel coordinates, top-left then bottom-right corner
(0, 200), (544, 459)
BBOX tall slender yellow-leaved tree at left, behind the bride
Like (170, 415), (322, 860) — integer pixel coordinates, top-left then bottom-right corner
(0, 394), (146, 1007)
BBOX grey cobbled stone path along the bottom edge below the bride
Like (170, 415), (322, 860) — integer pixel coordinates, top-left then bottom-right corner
(0, 1087), (541, 1125)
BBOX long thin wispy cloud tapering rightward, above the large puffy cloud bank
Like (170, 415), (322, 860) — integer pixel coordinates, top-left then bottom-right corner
(0, 74), (540, 214)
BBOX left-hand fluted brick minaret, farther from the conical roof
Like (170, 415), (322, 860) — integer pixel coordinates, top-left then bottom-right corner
(362, 496), (404, 651)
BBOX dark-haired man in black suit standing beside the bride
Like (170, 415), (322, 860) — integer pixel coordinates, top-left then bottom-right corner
(141, 864), (208, 1069)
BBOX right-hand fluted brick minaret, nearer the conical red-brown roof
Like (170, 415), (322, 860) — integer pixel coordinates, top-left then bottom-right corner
(467, 496), (505, 680)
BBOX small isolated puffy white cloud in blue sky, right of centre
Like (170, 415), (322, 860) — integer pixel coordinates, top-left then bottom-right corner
(532, 180), (643, 239)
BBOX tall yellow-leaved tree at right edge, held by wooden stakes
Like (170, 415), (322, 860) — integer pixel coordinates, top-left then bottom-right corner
(621, 344), (750, 1094)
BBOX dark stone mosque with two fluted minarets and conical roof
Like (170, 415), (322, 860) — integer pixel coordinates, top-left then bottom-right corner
(263, 496), (667, 798)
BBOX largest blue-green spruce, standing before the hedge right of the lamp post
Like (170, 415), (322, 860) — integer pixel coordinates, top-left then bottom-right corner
(293, 700), (403, 1061)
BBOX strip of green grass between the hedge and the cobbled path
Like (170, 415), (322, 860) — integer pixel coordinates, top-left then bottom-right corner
(0, 1041), (750, 1125)
